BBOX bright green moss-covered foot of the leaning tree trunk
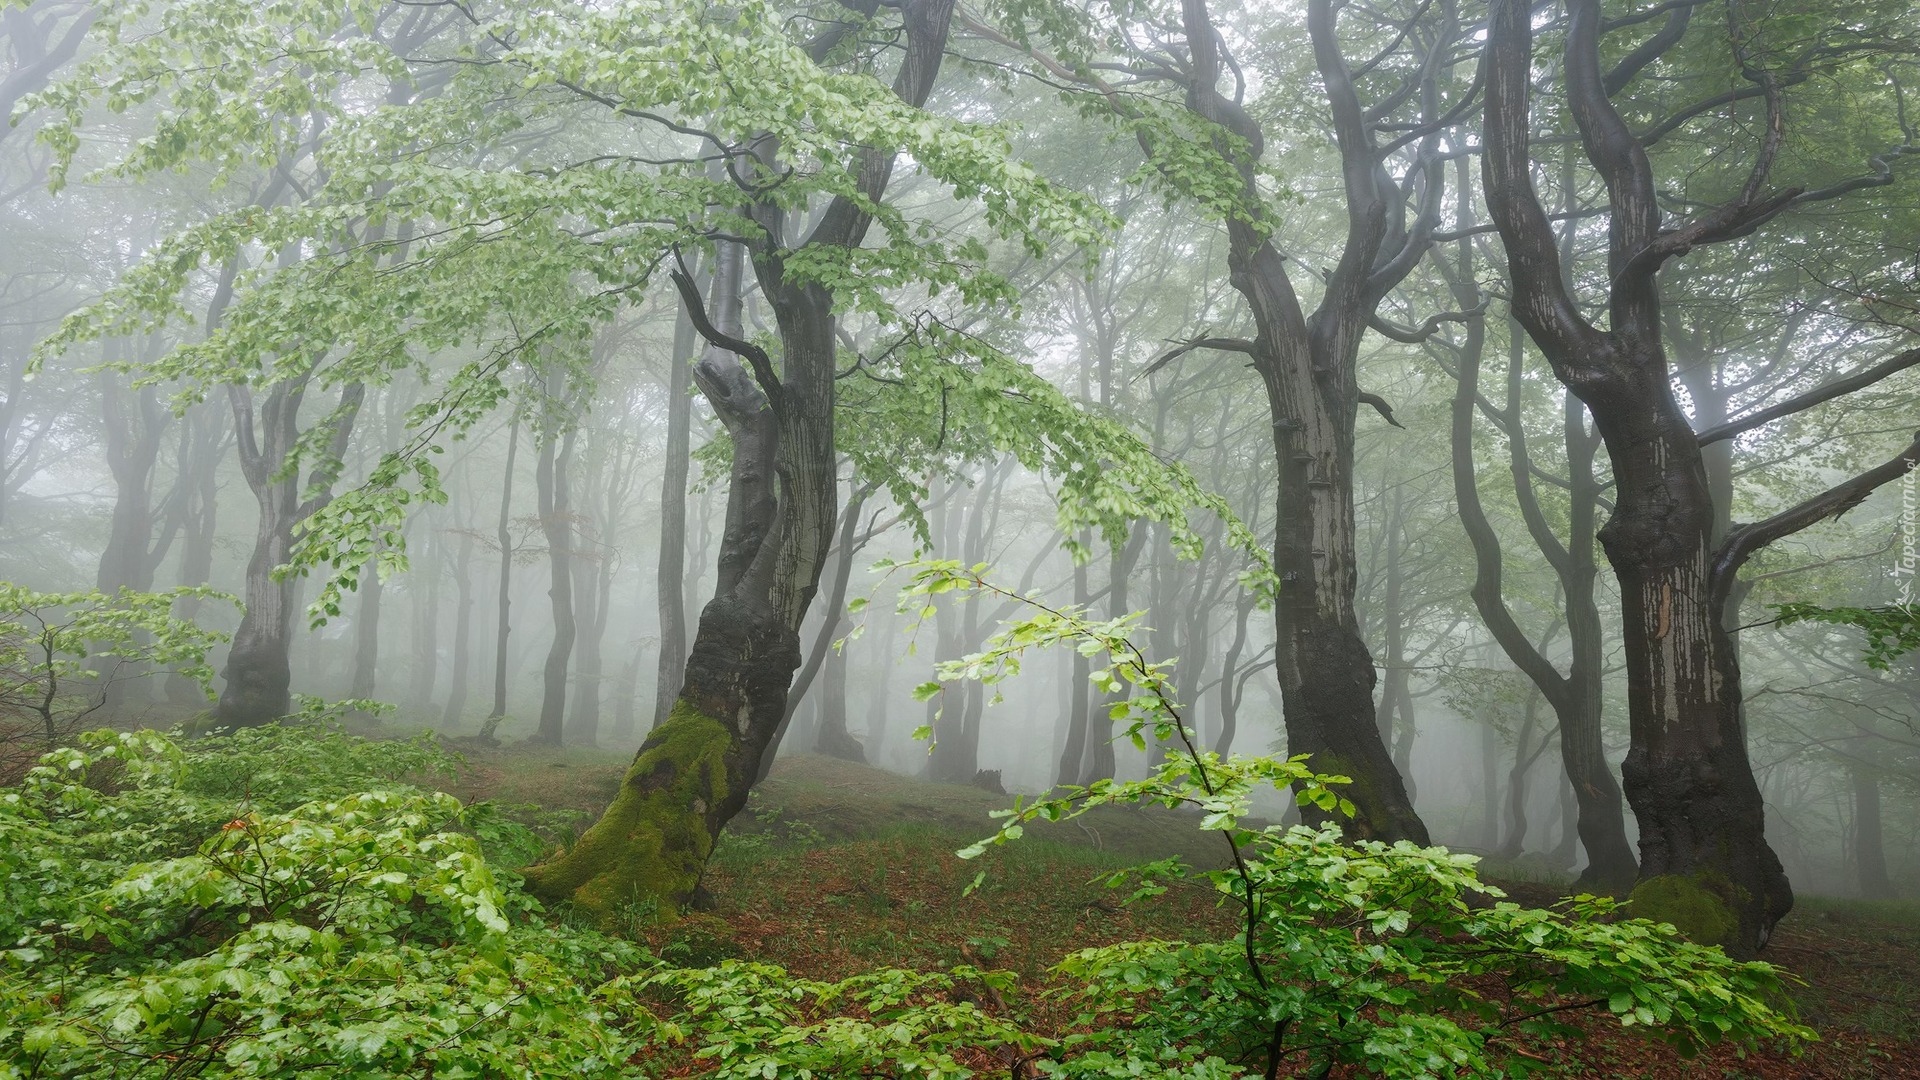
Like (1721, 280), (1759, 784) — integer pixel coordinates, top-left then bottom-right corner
(524, 700), (733, 922)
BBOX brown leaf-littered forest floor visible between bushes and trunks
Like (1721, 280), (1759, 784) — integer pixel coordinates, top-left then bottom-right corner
(447, 748), (1920, 1080)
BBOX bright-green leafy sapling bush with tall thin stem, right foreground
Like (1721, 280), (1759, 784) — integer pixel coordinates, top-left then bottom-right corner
(902, 561), (1814, 1080)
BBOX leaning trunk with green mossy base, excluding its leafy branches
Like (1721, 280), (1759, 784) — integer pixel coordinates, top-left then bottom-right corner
(526, 0), (952, 919)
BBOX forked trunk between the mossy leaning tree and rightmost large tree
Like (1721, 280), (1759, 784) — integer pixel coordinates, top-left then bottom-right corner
(1148, 0), (1457, 844)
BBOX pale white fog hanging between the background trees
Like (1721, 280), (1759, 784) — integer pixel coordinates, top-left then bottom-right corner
(0, 0), (1920, 914)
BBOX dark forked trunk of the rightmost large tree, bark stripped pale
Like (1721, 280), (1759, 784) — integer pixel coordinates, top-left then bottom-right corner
(1482, 0), (1793, 953)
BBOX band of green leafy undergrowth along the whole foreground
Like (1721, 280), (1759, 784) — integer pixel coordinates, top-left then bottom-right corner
(0, 721), (1812, 1080)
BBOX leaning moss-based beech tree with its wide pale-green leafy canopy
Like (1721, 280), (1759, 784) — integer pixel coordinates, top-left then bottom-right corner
(42, 0), (1258, 915)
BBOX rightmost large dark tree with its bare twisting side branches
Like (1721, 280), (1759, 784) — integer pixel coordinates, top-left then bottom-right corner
(1482, 0), (1920, 951)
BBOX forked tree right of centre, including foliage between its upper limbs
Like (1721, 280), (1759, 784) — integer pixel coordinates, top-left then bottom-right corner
(960, 0), (1471, 842)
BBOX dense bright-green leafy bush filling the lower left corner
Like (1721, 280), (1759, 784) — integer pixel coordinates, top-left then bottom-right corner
(0, 728), (649, 1080)
